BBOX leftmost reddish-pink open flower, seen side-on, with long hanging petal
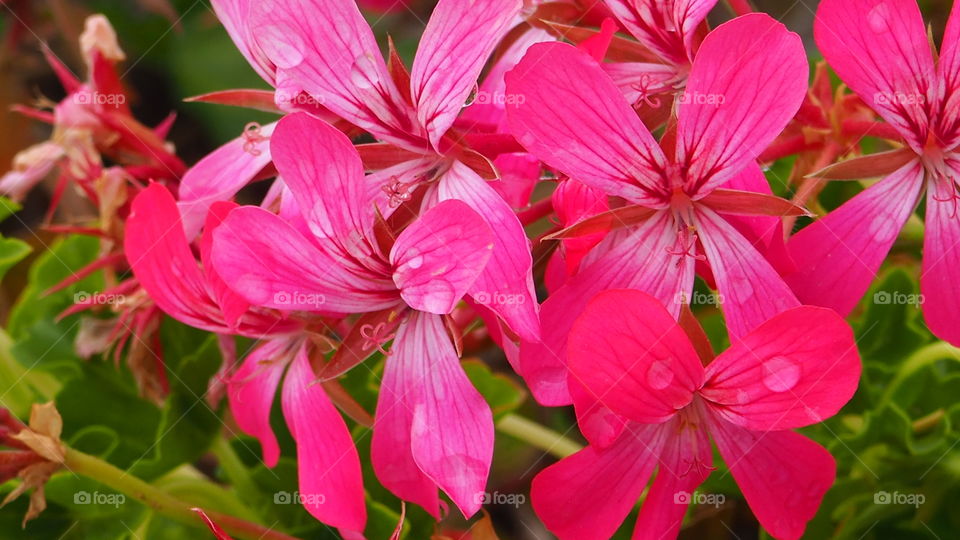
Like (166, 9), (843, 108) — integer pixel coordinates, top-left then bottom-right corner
(124, 184), (366, 531)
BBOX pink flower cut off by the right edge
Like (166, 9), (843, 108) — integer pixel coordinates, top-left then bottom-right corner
(787, 0), (960, 345)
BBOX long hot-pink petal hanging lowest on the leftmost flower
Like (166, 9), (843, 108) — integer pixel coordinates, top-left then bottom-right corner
(281, 347), (367, 531)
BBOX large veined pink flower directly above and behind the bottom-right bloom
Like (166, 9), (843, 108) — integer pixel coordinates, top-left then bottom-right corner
(507, 14), (807, 405)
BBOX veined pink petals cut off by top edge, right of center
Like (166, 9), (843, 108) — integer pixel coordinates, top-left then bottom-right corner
(606, 0), (717, 65)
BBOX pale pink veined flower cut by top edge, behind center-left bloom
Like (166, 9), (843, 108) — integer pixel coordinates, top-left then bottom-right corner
(210, 0), (540, 339)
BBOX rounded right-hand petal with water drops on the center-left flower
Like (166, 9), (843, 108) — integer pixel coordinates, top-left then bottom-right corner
(390, 200), (494, 315)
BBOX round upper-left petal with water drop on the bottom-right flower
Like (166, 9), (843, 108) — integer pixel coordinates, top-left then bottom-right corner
(567, 289), (703, 423)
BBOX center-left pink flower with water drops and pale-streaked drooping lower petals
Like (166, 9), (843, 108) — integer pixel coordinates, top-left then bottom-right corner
(212, 113), (493, 516)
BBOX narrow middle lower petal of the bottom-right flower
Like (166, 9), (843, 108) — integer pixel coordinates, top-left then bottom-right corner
(631, 416), (713, 540)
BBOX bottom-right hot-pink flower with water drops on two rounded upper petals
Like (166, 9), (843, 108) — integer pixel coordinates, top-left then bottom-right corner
(531, 290), (860, 540)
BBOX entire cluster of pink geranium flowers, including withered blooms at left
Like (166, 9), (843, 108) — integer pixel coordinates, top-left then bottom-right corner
(0, 0), (960, 540)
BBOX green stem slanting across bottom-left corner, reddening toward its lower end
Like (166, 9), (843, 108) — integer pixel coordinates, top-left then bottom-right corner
(64, 448), (296, 540)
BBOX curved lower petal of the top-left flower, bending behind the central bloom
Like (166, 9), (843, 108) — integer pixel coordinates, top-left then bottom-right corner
(437, 162), (540, 339)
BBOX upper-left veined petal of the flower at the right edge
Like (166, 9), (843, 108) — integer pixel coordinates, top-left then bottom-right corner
(814, 0), (935, 152)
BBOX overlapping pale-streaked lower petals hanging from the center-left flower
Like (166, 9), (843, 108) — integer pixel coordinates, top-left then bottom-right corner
(372, 312), (493, 517)
